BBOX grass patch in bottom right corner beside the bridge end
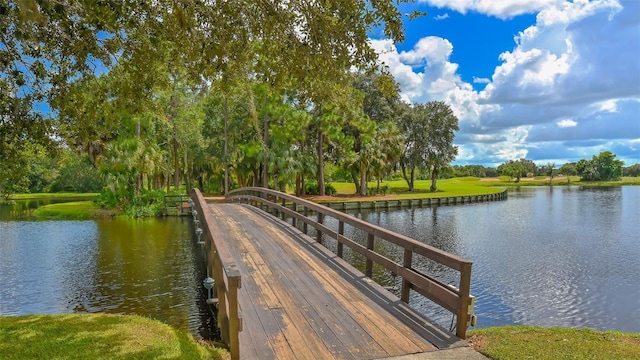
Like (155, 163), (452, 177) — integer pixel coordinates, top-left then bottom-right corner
(468, 326), (640, 360)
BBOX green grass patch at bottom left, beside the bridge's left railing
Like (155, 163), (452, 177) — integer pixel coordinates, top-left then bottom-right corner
(0, 314), (226, 360)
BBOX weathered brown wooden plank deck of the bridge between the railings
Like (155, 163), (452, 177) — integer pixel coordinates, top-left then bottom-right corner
(209, 204), (467, 359)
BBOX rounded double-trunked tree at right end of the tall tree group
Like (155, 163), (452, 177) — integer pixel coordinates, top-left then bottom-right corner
(400, 101), (459, 191)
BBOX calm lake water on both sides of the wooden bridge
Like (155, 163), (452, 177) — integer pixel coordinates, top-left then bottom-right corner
(0, 187), (640, 337)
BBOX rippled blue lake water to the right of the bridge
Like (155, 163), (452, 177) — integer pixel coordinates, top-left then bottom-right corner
(336, 186), (640, 332)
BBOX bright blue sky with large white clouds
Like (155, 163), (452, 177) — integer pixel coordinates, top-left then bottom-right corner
(371, 0), (640, 167)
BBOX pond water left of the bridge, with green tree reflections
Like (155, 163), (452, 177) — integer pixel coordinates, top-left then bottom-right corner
(0, 202), (212, 338)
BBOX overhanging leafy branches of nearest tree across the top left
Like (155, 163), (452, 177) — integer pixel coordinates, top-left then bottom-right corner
(0, 0), (404, 173)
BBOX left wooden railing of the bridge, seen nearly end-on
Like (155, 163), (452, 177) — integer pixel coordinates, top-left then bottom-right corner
(191, 189), (242, 360)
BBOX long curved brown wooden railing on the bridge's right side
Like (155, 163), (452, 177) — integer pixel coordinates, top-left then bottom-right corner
(226, 187), (472, 339)
